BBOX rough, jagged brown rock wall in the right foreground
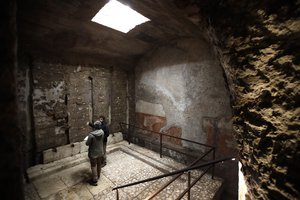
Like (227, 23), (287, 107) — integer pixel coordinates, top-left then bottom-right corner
(190, 0), (300, 199)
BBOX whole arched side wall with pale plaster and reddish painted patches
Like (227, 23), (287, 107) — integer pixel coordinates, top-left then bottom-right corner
(136, 38), (238, 199)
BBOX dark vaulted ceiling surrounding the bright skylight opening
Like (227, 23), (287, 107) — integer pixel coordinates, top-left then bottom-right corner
(17, 0), (201, 69)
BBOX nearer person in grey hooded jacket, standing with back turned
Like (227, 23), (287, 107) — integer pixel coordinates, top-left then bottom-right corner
(85, 121), (104, 186)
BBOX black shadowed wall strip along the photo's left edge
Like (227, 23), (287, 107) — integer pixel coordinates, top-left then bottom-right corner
(0, 1), (24, 200)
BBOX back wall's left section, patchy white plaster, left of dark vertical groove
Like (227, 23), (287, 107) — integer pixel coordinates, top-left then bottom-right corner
(32, 63), (68, 152)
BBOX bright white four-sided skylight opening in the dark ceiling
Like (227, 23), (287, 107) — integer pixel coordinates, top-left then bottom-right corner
(92, 0), (149, 33)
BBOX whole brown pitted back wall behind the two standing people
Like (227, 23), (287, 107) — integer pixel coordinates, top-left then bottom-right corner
(18, 59), (133, 165)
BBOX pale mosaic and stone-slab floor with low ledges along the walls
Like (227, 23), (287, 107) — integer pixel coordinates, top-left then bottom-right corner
(24, 141), (222, 200)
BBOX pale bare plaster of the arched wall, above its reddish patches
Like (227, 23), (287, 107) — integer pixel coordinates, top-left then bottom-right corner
(136, 39), (231, 145)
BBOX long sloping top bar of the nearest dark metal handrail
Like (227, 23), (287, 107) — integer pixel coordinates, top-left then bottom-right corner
(112, 157), (235, 196)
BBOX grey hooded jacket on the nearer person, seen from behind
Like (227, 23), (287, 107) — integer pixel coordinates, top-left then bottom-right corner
(85, 129), (104, 158)
